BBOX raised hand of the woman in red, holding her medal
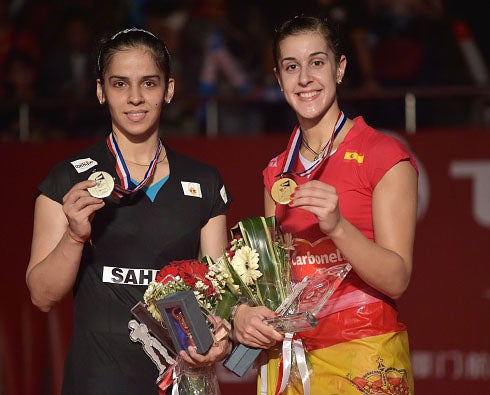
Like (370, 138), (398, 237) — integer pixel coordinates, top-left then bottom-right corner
(289, 180), (341, 235)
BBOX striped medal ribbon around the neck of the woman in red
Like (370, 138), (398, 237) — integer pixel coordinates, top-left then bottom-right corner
(278, 111), (347, 177)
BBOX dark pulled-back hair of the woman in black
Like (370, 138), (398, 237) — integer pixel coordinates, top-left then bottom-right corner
(96, 27), (170, 84)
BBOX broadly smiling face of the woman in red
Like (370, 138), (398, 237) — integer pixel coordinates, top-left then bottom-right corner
(275, 31), (346, 123)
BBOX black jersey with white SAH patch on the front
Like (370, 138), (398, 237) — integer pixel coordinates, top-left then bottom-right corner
(39, 143), (231, 395)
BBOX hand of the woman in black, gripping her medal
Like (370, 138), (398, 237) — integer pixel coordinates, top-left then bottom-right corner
(63, 180), (105, 240)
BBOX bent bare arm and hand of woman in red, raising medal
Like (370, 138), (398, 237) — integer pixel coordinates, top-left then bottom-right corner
(292, 161), (417, 299)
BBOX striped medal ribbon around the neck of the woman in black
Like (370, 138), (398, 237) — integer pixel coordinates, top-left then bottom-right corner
(106, 132), (163, 199)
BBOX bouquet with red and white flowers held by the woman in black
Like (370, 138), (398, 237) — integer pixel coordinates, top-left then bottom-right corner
(129, 257), (231, 395)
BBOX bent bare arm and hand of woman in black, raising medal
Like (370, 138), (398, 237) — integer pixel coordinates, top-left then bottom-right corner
(26, 181), (104, 311)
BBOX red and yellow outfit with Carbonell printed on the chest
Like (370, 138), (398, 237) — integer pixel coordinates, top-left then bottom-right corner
(259, 117), (417, 394)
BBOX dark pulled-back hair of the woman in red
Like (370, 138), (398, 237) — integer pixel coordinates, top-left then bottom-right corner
(272, 15), (342, 67)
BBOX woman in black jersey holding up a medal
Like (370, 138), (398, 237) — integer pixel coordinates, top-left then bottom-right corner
(26, 28), (231, 395)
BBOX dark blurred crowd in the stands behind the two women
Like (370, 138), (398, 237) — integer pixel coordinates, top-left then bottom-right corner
(0, 0), (490, 141)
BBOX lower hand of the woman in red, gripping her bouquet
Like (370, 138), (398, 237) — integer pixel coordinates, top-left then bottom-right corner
(233, 304), (284, 348)
